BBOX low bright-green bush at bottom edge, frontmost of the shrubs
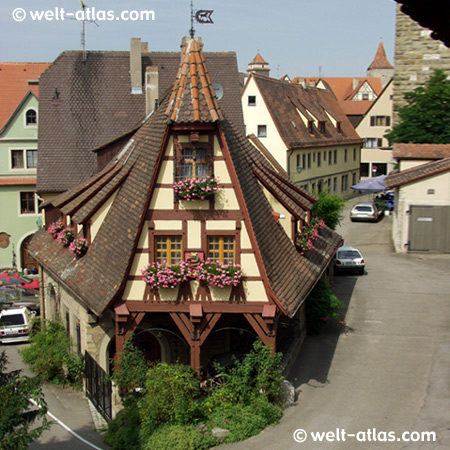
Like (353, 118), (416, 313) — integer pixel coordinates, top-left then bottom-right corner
(143, 424), (219, 450)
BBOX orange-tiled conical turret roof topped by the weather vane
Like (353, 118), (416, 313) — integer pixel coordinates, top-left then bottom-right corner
(166, 39), (223, 123)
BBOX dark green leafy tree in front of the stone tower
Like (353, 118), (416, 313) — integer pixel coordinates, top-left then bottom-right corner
(384, 70), (450, 144)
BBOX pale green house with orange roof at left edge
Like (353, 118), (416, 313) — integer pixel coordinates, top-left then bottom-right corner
(0, 63), (49, 270)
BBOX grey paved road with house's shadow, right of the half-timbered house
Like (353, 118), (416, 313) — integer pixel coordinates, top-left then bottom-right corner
(223, 197), (450, 450)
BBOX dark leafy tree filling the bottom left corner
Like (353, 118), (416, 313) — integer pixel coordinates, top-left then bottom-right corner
(0, 352), (49, 450)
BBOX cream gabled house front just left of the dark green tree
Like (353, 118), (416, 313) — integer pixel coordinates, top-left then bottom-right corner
(356, 80), (394, 179)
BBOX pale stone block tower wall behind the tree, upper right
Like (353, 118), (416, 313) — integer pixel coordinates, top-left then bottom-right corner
(394, 6), (450, 125)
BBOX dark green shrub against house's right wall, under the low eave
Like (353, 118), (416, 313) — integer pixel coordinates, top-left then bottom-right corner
(306, 280), (344, 334)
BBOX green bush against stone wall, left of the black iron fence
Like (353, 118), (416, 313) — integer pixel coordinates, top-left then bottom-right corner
(21, 320), (84, 387)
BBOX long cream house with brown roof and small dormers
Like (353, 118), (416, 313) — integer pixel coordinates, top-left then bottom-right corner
(242, 73), (362, 196)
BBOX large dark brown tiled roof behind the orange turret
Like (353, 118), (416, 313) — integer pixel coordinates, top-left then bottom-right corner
(37, 51), (243, 193)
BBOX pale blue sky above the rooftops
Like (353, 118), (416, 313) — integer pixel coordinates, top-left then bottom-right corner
(0, 0), (397, 78)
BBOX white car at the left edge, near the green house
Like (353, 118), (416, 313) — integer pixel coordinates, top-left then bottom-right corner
(0, 306), (36, 344)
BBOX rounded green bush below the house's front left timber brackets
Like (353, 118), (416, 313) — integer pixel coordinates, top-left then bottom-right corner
(139, 363), (201, 435)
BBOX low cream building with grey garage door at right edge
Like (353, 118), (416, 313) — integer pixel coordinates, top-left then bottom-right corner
(386, 144), (450, 253)
